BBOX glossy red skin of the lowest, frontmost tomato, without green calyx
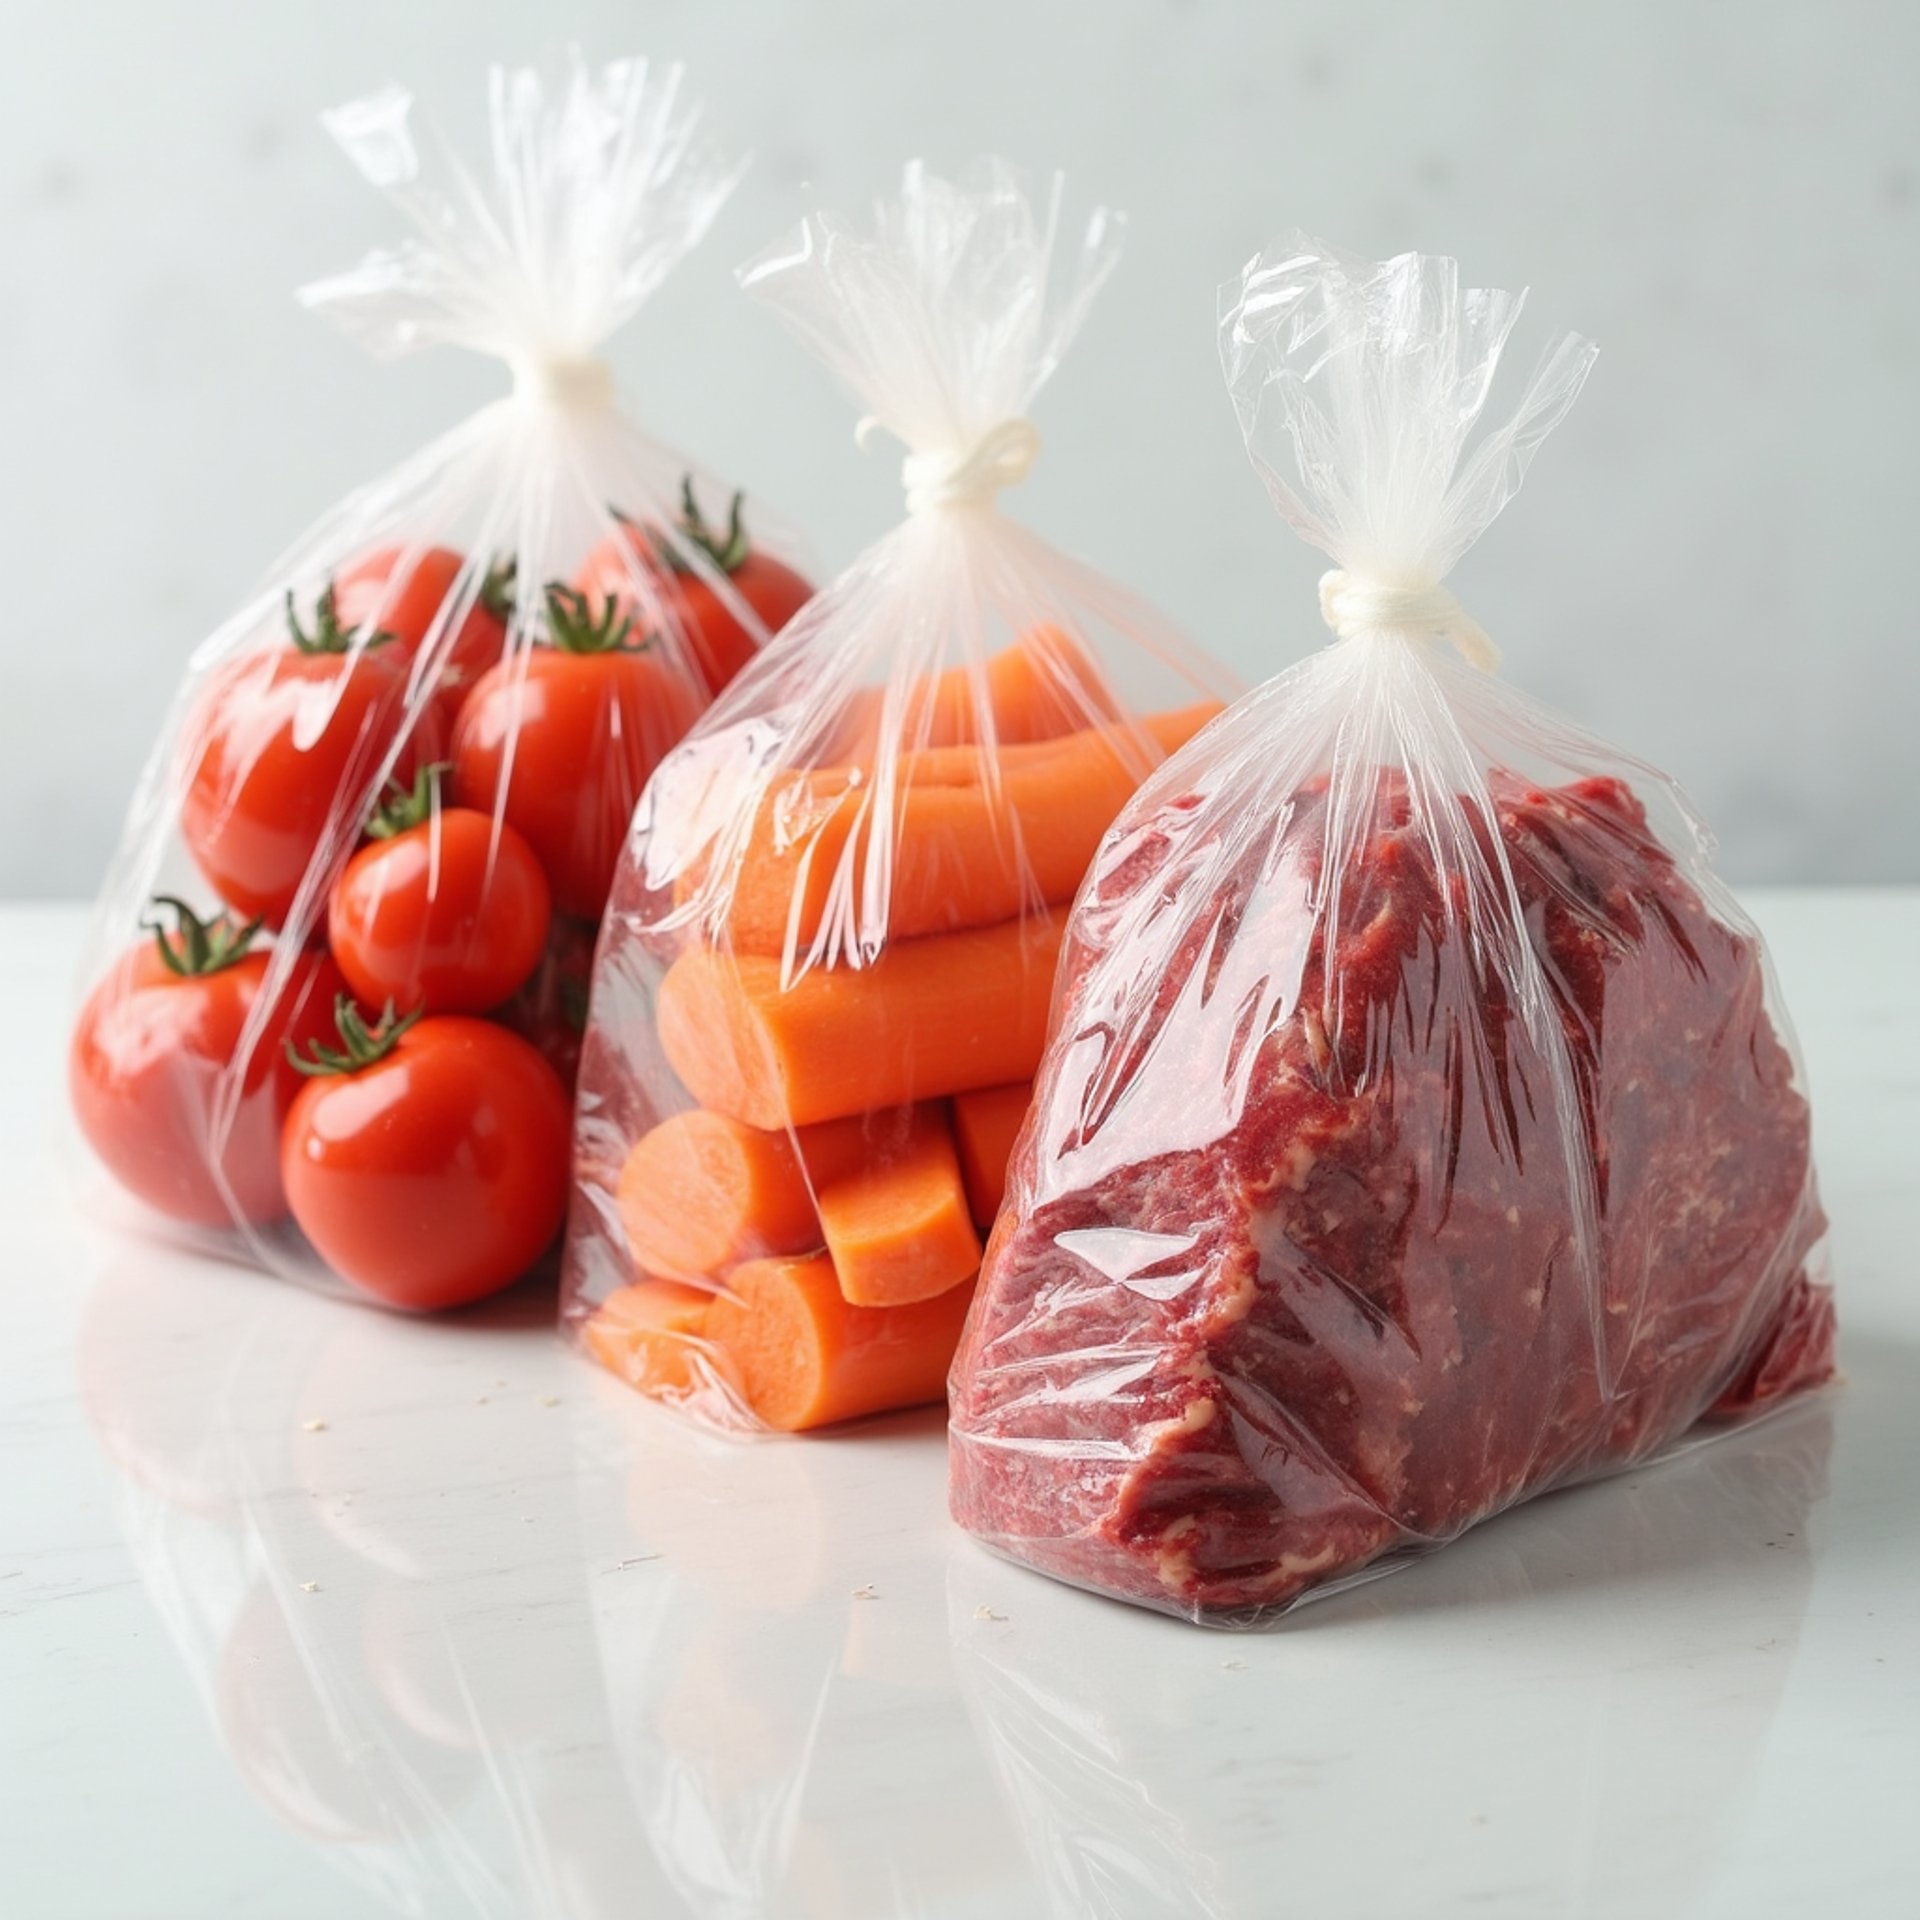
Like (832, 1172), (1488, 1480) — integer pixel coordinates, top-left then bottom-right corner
(280, 1014), (572, 1313)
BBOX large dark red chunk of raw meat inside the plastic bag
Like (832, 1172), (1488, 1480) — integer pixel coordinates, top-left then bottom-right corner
(952, 774), (1834, 1622)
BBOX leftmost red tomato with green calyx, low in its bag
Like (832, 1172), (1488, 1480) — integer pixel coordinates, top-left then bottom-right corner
(67, 900), (346, 1225)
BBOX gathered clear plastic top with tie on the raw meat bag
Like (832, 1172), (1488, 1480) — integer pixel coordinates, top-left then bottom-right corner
(1221, 232), (1597, 666)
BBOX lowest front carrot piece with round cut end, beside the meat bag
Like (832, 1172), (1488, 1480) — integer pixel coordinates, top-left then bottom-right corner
(707, 1254), (973, 1432)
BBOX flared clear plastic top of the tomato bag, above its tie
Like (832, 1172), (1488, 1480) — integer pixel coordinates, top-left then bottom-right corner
(300, 56), (741, 378)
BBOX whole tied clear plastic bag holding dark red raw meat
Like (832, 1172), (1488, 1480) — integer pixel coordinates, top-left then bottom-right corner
(952, 236), (1834, 1624)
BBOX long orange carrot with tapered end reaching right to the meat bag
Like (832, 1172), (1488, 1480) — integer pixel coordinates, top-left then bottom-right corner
(726, 701), (1219, 954)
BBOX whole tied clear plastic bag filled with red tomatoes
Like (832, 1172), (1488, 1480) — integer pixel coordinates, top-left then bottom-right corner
(71, 60), (808, 1309)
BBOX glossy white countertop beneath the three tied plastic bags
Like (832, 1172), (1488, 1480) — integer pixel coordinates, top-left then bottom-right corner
(0, 891), (1920, 1920)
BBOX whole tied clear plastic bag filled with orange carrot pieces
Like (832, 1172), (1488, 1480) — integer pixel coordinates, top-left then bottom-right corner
(564, 163), (1229, 1430)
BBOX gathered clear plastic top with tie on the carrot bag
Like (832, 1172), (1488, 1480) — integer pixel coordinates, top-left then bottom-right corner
(739, 159), (1125, 511)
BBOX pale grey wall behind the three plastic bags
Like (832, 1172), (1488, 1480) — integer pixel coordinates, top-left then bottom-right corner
(0, 0), (1920, 895)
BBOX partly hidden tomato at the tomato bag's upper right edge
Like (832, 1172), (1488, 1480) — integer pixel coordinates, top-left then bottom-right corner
(574, 480), (814, 693)
